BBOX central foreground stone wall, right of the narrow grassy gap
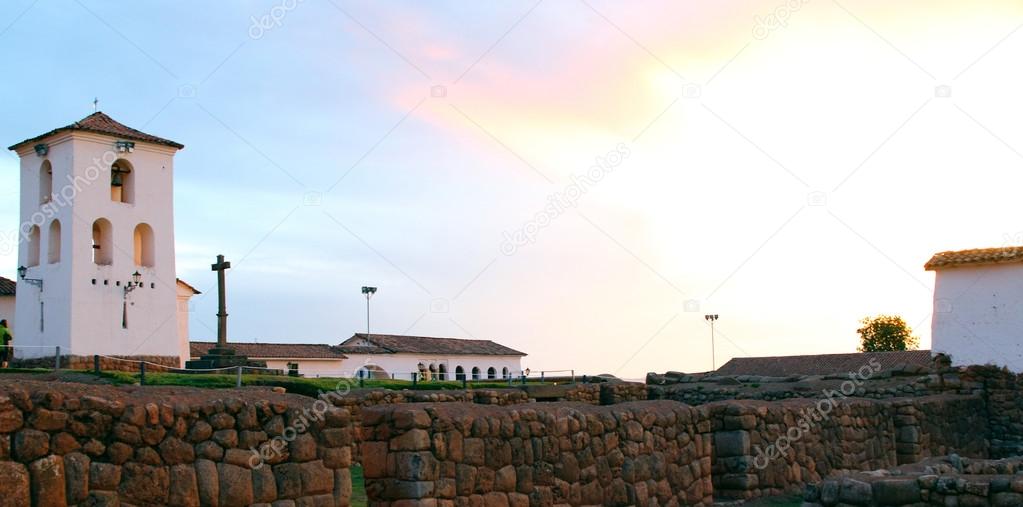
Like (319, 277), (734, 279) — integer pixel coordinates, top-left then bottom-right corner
(361, 402), (712, 506)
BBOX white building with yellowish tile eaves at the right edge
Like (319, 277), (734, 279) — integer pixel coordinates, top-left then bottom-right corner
(925, 246), (1023, 372)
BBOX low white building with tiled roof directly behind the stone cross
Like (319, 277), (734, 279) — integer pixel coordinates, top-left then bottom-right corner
(191, 341), (351, 377)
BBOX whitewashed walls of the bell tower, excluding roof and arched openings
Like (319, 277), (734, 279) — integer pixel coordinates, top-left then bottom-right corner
(14, 132), (181, 357)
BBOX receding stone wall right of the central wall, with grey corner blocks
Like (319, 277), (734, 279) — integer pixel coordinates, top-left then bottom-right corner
(706, 395), (987, 499)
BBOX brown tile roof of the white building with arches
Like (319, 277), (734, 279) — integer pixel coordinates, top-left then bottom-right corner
(338, 333), (526, 356)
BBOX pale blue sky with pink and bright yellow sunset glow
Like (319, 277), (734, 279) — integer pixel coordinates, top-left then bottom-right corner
(0, 0), (1023, 378)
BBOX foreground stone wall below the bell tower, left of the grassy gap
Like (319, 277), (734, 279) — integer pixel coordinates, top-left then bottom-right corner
(0, 381), (352, 507)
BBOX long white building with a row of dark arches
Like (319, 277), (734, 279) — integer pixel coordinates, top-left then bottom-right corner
(338, 333), (526, 380)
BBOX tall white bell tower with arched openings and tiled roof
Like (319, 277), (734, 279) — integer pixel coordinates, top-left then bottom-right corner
(9, 112), (196, 365)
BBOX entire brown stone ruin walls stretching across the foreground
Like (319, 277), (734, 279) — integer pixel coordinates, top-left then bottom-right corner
(0, 361), (1023, 507)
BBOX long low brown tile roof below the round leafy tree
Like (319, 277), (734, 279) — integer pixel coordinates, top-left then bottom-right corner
(717, 351), (931, 377)
